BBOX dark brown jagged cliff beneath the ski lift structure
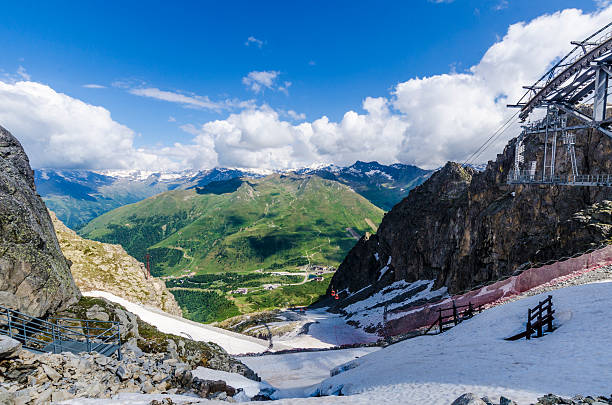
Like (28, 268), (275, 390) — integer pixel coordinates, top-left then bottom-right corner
(328, 124), (612, 300)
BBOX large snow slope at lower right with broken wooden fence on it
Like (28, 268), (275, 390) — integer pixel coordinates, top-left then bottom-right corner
(300, 283), (612, 404)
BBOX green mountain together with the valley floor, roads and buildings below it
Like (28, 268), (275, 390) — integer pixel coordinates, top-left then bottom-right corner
(79, 174), (383, 322)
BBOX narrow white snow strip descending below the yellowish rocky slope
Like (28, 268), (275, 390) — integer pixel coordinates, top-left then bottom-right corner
(83, 291), (288, 354)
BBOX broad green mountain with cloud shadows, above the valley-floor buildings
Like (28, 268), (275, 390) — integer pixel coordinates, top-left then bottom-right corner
(80, 174), (383, 276)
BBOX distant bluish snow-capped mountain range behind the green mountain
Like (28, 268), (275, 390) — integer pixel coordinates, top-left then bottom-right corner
(35, 161), (432, 229)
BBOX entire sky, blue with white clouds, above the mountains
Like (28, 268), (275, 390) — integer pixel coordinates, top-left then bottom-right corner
(0, 0), (612, 170)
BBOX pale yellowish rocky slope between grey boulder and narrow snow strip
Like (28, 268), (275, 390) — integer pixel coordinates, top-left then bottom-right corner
(49, 212), (182, 316)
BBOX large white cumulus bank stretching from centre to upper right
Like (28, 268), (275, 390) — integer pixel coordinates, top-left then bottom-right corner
(180, 9), (612, 168)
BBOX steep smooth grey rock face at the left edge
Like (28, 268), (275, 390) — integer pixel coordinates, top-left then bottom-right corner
(0, 127), (80, 316)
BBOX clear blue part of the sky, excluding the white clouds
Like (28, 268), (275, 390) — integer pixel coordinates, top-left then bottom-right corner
(0, 0), (606, 167)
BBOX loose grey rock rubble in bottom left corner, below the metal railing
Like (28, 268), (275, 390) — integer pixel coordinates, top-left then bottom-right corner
(0, 338), (243, 405)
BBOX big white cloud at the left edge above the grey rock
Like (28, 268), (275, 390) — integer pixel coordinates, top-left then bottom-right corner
(0, 81), (172, 169)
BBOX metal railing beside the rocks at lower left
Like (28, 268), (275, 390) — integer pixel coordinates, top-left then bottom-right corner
(0, 306), (121, 359)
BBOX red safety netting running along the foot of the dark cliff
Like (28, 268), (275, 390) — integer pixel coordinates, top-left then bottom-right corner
(386, 246), (612, 335)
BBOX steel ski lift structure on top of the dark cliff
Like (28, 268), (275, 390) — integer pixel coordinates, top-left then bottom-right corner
(507, 23), (612, 187)
